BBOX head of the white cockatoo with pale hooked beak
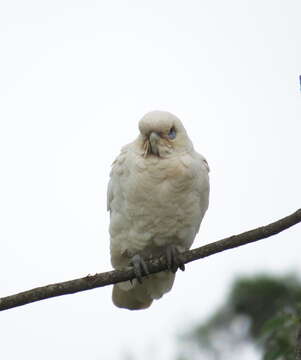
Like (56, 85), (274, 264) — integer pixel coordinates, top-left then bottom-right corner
(139, 111), (192, 157)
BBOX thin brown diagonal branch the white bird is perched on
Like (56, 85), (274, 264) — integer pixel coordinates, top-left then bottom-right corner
(0, 209), (301, 311)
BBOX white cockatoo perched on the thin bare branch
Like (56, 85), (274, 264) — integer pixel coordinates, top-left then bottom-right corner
(108, 111), (209, 310)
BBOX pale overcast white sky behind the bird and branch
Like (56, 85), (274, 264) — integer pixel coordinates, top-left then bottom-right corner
(0, 0), (301, 360)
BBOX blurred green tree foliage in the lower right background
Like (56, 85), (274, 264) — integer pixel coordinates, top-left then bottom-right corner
(177, 275), (301, 360)
